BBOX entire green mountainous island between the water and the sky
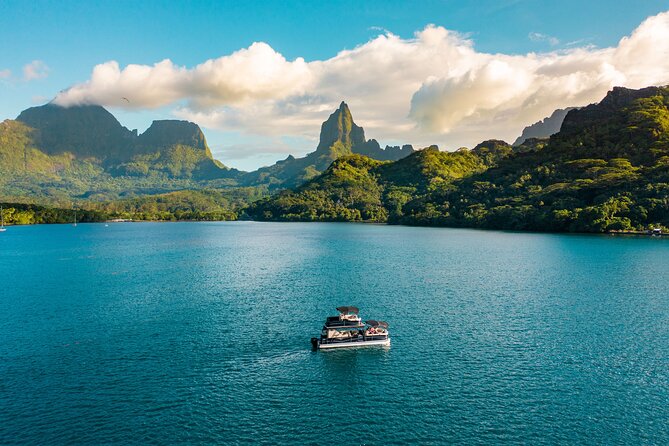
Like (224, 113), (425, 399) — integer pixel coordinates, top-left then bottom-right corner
(0, 87), (669, 232)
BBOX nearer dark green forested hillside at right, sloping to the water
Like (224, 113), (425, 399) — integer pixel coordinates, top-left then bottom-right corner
(247, 87), (669, 232)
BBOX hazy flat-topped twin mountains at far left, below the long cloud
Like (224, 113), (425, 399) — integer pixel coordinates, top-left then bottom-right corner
(0, 104), (239, 205)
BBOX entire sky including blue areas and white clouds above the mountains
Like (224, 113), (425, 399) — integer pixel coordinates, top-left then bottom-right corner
(0, 0), (669, 170)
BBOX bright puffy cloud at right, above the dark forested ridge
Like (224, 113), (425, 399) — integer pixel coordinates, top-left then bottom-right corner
(411, 13), (669, 137)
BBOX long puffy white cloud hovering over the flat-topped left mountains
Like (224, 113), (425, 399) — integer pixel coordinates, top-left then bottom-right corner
(55, 43), (310, 110)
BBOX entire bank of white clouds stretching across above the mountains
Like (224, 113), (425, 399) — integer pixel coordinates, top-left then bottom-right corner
(55, 12), (669, 161)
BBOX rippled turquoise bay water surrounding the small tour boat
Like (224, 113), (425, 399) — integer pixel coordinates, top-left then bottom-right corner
(0, 222), (669, 445)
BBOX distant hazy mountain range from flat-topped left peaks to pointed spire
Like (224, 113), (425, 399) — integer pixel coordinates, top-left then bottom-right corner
(0, 102), (413, 206)
